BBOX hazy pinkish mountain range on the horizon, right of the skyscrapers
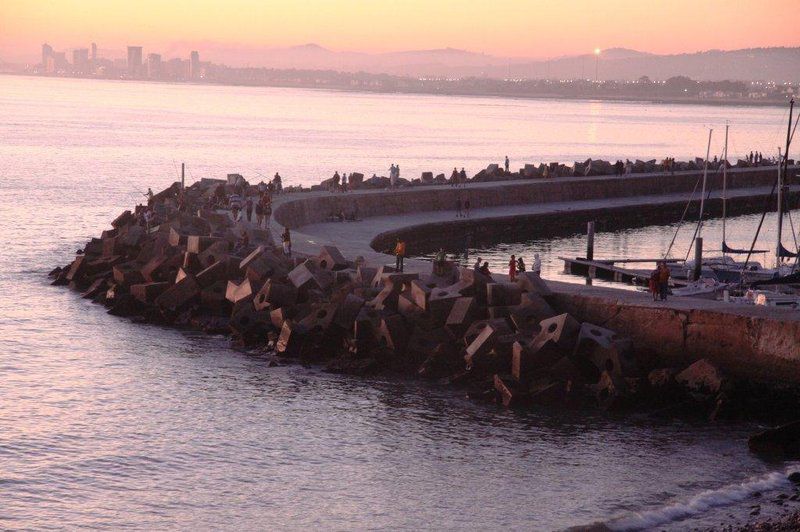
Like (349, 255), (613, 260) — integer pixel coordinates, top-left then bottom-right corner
(225, 44), (800, 82)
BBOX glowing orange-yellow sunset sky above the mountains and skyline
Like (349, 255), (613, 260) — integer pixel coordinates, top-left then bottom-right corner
(0, 0), (800, 64)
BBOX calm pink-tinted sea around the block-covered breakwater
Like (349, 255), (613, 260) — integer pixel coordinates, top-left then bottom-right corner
(0, 76), (800, 530)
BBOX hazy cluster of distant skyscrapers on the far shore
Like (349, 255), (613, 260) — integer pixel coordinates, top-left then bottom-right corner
(37, 43), (203, 81)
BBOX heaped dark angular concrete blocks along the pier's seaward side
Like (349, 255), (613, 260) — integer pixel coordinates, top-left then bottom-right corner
(52, 164), (800, 422)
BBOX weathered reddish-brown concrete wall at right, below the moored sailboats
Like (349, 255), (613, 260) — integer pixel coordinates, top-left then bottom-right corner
(549, 281), (800, 384)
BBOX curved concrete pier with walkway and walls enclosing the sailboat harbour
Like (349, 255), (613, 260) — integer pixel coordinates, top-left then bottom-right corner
(271, 166), (800, 384)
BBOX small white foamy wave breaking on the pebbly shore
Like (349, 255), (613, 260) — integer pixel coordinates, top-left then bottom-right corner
(606, 467), (797, 531)
